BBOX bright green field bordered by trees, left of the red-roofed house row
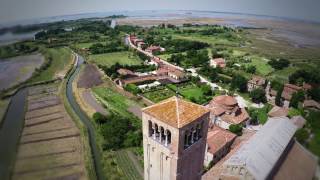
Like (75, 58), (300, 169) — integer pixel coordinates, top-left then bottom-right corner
(89, 51), (142, 67)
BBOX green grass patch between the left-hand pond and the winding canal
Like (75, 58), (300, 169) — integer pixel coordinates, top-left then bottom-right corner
(31, 48), (72, 82)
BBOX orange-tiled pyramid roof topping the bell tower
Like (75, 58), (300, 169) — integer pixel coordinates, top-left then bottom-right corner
(142, 96), (209, 128)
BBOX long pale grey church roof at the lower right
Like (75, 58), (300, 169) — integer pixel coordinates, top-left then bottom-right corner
(224, 117), (297, 179)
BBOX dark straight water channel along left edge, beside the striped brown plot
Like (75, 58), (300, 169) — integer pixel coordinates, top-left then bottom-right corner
(0, 89), (27, 180)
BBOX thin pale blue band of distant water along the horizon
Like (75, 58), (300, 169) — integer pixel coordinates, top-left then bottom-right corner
(0, 9), (320, 28)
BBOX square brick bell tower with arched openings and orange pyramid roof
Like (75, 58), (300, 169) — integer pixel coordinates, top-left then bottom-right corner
(142, 97), (209, 180)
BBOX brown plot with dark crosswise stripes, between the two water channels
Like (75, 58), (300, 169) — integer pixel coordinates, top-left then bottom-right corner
(12, 84), (87, 179)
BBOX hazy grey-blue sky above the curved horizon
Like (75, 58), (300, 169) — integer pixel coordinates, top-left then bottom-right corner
(0, 0), (320, 23)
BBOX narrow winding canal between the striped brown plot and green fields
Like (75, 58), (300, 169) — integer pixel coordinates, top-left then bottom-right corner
(66, 56), (105, 180)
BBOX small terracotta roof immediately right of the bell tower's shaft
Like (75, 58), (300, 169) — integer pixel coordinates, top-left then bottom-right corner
(207, 126), (237, 154)
